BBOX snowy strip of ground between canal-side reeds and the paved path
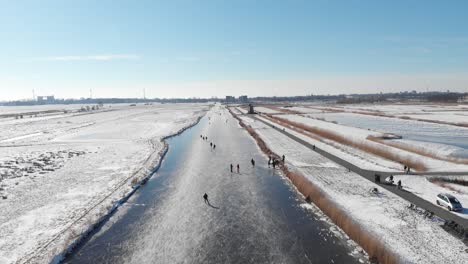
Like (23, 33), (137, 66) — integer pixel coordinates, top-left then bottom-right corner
(241, 114), (468, 263)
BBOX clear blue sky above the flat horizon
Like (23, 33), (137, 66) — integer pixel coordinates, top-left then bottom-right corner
(0, 0), (468, 100)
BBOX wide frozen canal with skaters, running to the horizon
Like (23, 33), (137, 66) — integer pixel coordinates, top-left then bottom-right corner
(64, 107), (358, 263)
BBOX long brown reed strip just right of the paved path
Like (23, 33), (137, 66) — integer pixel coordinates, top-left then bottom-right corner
(264, 115), (427, 171)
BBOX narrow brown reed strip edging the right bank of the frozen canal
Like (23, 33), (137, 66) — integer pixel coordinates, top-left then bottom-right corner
(229, 109), (400, 264)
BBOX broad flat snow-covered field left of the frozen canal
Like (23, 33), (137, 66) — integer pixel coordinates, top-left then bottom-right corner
(0, 104), (209, 263)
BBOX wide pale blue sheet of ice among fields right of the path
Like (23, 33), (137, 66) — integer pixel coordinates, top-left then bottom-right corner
(309, 113), (468, 157)
